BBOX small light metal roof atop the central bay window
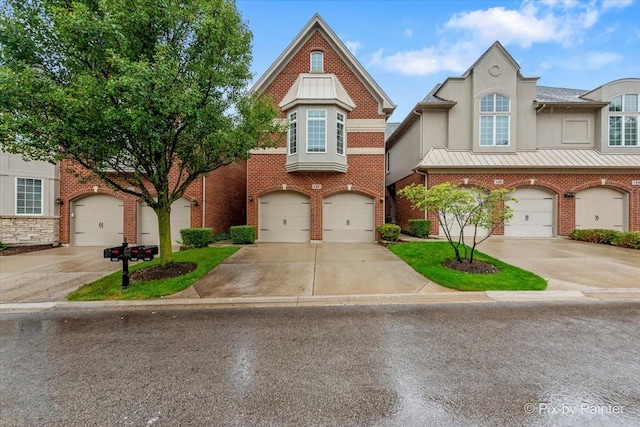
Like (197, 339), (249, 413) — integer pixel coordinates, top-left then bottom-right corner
(278, 73), (356, 111)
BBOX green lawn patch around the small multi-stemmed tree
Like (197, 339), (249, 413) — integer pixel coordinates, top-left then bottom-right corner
(389, 242), (547, 291)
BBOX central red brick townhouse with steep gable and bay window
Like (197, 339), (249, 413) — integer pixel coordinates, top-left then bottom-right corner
(247, 15), (395, 242)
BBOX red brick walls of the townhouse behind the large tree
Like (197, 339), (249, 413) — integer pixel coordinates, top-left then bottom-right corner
(60, 160), (246, 244)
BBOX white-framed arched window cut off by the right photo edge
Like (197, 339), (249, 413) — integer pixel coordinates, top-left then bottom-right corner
(609, 93), (640, 147)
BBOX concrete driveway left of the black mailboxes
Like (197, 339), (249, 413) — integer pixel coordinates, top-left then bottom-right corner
(0, 247), (122, 303)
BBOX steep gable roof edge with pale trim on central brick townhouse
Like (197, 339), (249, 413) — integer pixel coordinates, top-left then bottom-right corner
(251, 13), (396, 114)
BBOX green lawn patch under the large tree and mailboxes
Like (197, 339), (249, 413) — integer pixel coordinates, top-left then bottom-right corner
(67, 246), (240, 301)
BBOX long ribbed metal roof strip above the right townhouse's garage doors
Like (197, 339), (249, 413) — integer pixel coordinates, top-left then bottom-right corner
(415, 148), (640, 172)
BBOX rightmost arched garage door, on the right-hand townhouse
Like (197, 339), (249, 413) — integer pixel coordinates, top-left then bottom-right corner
(576, 188), (625, 231)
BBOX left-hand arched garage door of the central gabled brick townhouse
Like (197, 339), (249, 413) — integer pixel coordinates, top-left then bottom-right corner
(258, 191), (311, 242)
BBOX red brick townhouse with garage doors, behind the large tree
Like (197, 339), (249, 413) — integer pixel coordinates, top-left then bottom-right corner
(60, 160), (246, 246)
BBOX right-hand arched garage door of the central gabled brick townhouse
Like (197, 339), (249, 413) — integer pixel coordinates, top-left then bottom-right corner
(322, 193), (376, 242)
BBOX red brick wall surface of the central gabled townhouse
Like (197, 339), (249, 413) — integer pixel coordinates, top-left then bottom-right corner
(247, 24), (386, 240)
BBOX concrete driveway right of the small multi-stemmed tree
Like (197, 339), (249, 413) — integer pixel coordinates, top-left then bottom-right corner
(478, 237), (640, 291)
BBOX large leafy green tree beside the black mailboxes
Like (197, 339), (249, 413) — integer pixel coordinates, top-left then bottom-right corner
(0, 0), (282, 265)
